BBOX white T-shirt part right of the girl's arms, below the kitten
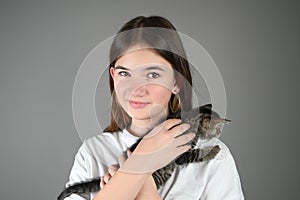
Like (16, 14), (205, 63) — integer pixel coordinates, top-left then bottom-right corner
(161, 138), (243, 199)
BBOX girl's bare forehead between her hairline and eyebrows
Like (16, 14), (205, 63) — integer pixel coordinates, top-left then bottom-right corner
(115, 48), (172, 69)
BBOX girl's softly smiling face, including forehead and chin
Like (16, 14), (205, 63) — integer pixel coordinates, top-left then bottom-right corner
(110, 48), (179, 123)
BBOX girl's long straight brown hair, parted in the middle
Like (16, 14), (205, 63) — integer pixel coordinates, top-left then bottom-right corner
(104, 16), (192, 132)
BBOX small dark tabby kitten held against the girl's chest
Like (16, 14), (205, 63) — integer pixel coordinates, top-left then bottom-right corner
(57, 104), (230, 200)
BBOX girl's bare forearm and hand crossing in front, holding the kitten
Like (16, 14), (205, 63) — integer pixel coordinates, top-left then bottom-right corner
(94, 119), (195, 200)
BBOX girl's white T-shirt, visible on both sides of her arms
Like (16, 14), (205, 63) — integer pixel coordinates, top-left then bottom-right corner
(65, 130), (244, 200)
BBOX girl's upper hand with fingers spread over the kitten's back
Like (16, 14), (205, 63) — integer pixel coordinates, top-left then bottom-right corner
(120, 119), (195, 173)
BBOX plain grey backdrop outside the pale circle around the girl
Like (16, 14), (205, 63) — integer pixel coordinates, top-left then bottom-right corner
(0, 0), (300, 200)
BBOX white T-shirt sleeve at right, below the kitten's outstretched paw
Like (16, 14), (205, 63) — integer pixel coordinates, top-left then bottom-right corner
(200, 144), (244, 200)
